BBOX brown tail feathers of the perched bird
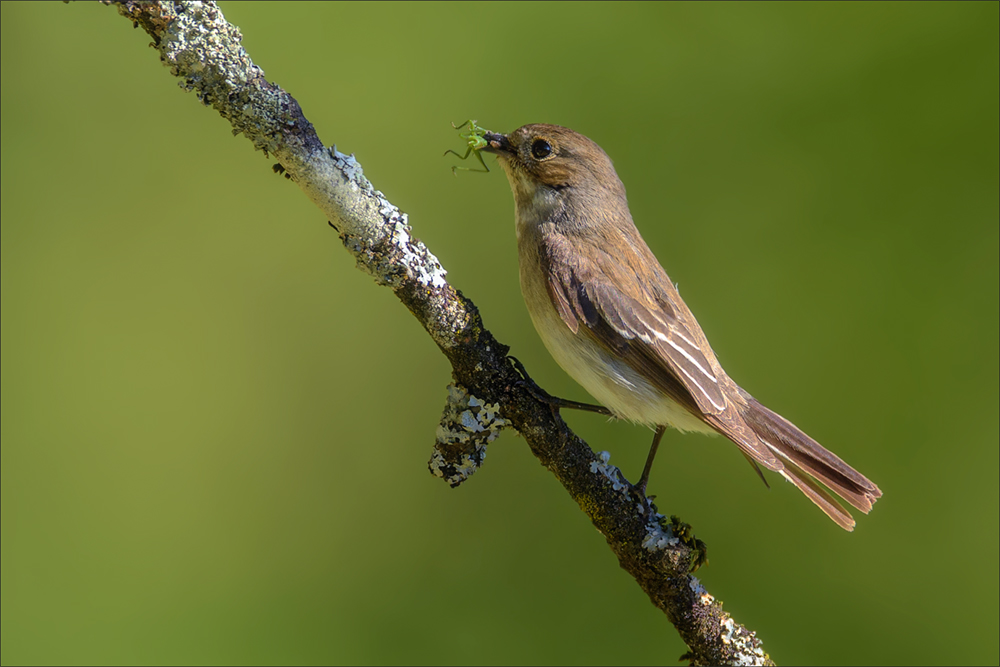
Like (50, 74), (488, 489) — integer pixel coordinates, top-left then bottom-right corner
(740, 392), (882, 530)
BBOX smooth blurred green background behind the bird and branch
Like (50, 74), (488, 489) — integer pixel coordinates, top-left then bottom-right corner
(0, 3), (1000, 664)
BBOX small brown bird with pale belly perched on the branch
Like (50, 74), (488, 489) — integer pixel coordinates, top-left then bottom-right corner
(482, 124), (882, 530)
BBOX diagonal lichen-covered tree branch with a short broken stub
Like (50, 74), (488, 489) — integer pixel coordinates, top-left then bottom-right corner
(111, 2), (773, 664)
